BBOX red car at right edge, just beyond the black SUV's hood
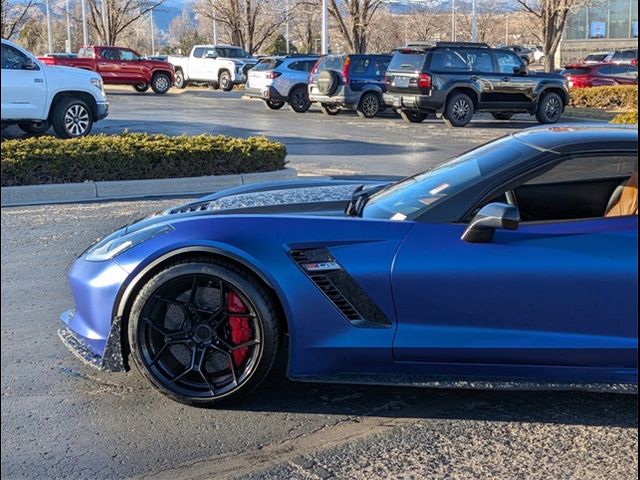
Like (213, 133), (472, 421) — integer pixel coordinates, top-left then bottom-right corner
(561, 63), (638, 88)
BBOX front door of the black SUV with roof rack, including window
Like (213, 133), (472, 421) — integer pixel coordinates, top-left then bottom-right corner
(494, 50), (536, 109)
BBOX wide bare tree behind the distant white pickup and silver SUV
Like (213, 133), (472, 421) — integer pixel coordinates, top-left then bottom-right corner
(193, 0), (285, 53)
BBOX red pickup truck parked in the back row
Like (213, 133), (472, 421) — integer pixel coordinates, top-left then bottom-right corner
(38, 46), (174, 94)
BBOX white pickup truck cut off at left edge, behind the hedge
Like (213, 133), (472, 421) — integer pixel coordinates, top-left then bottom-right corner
(1, 40), (109, 138)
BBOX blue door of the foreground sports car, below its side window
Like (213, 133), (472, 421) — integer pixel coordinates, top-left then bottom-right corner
(392, 157), (638, 376)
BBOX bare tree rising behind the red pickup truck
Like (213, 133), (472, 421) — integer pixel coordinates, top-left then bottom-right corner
(82, 0), (165, 45)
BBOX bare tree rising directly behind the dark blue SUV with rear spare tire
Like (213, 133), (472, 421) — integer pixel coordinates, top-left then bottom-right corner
(329, 0), (382, 53)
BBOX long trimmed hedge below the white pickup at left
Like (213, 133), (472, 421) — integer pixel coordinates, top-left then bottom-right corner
(2, 133), (287, 187)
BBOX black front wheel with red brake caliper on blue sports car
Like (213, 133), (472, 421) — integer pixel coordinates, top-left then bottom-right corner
(127, 258), (279, 407)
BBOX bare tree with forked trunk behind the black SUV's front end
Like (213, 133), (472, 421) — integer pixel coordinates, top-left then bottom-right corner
(516, 0), (591, 72)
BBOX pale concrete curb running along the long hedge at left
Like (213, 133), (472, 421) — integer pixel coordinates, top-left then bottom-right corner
(0, 168), (298, 207)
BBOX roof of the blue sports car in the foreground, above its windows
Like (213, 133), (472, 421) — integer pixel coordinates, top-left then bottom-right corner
(513, 123), (638, 154)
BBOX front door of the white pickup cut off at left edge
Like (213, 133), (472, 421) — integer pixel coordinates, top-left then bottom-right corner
(1, 43), (47, 120)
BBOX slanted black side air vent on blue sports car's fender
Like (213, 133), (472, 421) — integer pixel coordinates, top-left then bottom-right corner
(289, 248), (391, 328)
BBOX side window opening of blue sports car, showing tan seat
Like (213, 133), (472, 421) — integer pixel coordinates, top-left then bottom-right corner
(493, 156), (638, 222)
